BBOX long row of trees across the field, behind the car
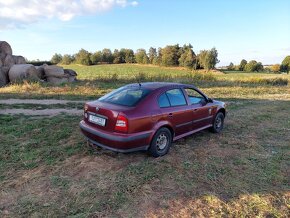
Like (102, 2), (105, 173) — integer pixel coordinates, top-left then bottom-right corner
(51, 44), (219, 70)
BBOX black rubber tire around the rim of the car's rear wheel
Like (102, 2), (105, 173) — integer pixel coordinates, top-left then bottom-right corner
(149, 128), (172, 157)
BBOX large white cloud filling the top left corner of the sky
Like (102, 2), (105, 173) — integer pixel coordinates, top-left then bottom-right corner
(0, 0), (138, 29)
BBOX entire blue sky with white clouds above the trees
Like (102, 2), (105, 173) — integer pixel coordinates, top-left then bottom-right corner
(0, 0), (290, 66)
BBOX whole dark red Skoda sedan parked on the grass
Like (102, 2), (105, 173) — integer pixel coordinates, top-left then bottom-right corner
(80, 82), (226, 157)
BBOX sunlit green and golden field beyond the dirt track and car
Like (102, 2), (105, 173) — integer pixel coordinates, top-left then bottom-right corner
(0, 64), (290, 100)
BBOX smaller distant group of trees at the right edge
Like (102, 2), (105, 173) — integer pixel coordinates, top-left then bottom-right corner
(227, 56), (290, 73)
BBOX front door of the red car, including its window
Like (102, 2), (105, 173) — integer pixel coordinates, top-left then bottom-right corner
(184, 88), (212, 130)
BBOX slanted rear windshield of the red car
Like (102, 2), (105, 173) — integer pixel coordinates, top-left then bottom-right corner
(99, 87), (150, 107)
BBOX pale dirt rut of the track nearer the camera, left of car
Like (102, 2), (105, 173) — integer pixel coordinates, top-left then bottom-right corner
(0, 109), (83, 116)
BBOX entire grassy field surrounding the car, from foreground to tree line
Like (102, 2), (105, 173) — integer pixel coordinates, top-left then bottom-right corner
(0, 65), (290, 217)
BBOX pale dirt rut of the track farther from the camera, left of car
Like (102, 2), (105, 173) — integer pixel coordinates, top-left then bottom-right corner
(0, 99), (84, 105)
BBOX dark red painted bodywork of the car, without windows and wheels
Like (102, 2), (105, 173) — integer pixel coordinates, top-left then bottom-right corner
(80, 83), (225, 152)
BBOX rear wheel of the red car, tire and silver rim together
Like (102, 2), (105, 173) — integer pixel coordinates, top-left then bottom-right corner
(149, 128), (172, 157)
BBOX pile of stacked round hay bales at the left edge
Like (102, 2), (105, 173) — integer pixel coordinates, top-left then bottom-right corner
(0, 41), (77, 87)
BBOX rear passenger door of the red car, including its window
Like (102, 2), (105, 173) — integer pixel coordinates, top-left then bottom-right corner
(158, 88), (192, 136)
